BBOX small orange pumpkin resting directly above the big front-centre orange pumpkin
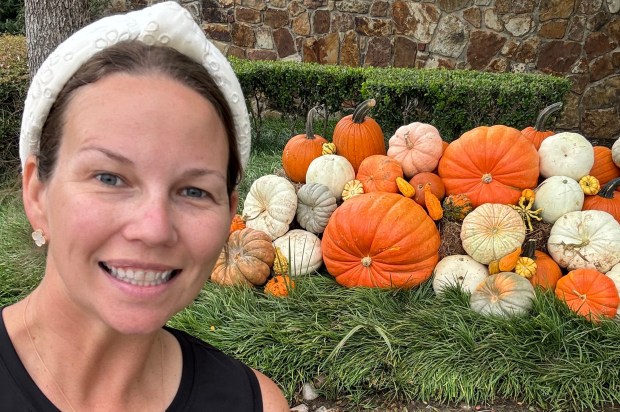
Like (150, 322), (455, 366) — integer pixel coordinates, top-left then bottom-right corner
(355, 155), (403, 193)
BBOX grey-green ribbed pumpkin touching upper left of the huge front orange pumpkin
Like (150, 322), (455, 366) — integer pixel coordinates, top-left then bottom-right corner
(295, 183), (338, 234)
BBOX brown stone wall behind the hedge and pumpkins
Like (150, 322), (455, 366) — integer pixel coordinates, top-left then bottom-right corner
(142, 0), (620, 140)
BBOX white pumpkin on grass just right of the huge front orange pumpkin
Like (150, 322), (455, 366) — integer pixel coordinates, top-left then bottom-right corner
(433, 255), (489, 294)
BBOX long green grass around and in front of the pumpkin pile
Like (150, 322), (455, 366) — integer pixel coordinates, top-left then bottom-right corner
(0, 117), (620, 411)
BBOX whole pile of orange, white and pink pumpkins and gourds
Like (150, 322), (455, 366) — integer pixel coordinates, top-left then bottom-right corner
(212, 99), (620, 320)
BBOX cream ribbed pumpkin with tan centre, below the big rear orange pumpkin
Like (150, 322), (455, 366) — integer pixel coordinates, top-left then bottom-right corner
(461, 203), (525, 265)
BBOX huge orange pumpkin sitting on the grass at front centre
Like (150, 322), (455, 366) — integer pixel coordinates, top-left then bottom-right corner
(321, 192), (440, 288)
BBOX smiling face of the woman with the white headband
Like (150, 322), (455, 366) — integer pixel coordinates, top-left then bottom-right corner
(25, 74), (236, 333)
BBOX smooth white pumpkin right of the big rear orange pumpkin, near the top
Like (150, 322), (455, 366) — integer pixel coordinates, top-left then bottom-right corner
(538, 132), (594, 181)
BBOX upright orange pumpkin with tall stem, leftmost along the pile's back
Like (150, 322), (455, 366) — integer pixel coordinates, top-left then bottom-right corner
(282, 107), (327, 183)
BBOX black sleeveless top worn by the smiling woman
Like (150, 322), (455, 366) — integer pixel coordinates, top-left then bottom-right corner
(0, 311), (263, 412)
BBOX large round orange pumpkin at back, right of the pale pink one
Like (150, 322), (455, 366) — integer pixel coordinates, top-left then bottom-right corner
(438, 125), (539, 206)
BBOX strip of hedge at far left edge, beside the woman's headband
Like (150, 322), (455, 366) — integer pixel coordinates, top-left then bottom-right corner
(0, 35), (29, 178)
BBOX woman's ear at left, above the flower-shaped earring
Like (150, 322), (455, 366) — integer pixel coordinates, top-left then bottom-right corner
(22, 155), (49, 236)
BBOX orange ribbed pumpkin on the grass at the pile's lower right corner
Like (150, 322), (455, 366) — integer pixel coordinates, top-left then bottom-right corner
(555, 269), (620, 321)
